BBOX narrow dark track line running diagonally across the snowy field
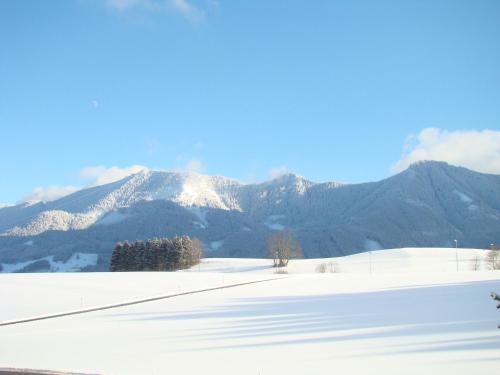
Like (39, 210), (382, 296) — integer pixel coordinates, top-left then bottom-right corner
(0, 277), (284, 327)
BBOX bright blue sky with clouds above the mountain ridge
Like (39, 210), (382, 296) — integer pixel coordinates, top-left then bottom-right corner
(0, 0), (500, 203)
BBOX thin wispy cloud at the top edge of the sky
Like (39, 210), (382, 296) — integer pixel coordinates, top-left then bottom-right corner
(105, 0), (205, 22)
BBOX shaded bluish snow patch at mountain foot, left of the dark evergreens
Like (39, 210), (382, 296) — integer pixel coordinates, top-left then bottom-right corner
(1, 253), (99, 272)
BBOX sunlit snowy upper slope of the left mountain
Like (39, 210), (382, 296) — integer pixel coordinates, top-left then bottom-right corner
(0, 170), (241, 236)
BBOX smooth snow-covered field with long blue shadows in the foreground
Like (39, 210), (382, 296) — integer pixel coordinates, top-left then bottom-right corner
(0, 249), (500, 374)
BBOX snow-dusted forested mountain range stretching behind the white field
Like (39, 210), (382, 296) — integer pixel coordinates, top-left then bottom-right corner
(0, 161), (500, 271)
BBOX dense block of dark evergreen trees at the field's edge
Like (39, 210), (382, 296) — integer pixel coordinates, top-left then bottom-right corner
(110, 236), (202, 272)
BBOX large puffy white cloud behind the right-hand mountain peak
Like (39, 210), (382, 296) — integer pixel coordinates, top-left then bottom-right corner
(391, 128), (500, 174)
